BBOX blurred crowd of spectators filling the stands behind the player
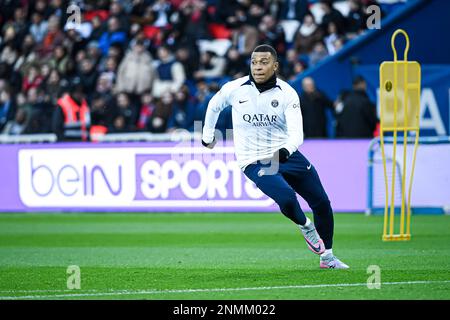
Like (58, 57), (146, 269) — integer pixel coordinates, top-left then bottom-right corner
(0, 0), (388, 140)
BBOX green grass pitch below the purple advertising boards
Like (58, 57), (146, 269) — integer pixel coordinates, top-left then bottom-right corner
(0, 213), (450, 299)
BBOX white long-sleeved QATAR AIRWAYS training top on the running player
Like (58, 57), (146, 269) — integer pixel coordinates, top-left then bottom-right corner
(202, 76), (303, 170)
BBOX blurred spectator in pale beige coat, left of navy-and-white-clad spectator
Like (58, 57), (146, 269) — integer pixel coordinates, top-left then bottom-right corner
(116, 41), (155, 94)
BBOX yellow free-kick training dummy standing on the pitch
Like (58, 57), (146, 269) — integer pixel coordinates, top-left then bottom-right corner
(380, 29), (421, 241)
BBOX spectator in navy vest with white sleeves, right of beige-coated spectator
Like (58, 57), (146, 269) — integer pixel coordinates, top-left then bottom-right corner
(152, 46), (186, 98)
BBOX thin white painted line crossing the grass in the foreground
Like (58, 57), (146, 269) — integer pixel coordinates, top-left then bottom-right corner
(0, 280), (450, 300)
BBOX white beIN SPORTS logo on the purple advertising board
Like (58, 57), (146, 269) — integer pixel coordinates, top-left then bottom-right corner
(19, 147), (273, 208)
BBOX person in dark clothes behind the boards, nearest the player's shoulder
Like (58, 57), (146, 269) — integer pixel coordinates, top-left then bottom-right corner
(300, 77), (333, 138)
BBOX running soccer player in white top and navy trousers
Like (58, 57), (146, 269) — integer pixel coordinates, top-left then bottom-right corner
(202, 45), (348, 269)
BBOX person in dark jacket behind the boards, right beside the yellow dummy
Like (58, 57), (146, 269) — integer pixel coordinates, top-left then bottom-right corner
(336, 77), (378, 138)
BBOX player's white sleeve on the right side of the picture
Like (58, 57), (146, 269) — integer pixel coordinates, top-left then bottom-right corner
(284, 93), (303, 154)
